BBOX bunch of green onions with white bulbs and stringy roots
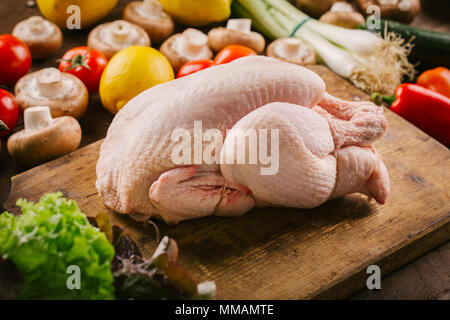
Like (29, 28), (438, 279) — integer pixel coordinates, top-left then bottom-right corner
(232, 0), (415, 94)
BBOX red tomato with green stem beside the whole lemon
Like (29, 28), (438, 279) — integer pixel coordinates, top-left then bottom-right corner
(59, 47), (108, 94)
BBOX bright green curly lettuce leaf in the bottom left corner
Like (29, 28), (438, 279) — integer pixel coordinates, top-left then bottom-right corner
(0, 193), (114, 299)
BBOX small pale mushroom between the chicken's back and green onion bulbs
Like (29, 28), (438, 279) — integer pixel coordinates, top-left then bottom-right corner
(266, 38), (317, 65)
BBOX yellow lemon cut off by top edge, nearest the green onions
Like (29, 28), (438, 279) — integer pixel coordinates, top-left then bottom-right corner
(159, 0), (232, 27)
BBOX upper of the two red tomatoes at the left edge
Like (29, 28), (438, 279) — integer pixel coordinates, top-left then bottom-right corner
(0, 34), (31, 85)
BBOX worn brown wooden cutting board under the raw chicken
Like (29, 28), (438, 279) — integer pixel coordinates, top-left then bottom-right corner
(5, 66), (450, 299)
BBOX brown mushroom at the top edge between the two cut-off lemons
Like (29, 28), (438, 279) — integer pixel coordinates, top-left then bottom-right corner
(123, 0), (175, 43)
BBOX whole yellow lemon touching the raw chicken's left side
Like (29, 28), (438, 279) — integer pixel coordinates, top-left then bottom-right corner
(99, 46), (174, 114)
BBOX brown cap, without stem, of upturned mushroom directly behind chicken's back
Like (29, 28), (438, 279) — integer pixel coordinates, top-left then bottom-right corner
(208, 27), (266, 53)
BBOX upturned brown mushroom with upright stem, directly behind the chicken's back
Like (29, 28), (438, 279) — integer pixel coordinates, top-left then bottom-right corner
(208, 19), (266, 53)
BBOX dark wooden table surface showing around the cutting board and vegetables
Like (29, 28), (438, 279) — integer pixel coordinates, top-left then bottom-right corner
(0, 0), (450, 299)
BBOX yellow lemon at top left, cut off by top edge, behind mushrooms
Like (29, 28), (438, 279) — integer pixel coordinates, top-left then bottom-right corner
(37, 0), (119, 28)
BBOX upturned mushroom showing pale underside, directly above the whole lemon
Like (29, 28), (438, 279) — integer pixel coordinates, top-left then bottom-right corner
(88, 20), (151, 59)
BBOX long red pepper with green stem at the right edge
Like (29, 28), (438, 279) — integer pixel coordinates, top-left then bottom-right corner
(372, 83), (450, 146)
